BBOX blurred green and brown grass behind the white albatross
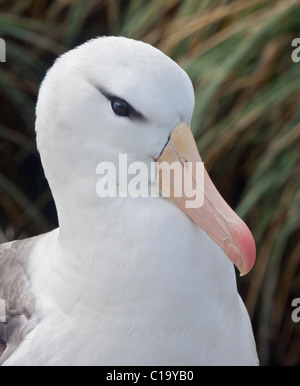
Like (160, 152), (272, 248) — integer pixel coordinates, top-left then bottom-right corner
(0, 0), (300, 365)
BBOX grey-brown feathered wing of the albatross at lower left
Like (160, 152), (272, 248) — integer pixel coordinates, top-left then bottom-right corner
(0, 237), (37, 365)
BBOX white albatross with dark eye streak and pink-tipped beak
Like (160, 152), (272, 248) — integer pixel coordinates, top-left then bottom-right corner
(0, 37), (258, 366)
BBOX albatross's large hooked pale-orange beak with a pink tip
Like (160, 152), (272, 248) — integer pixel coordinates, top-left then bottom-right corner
(156, 123), (256, 276)
